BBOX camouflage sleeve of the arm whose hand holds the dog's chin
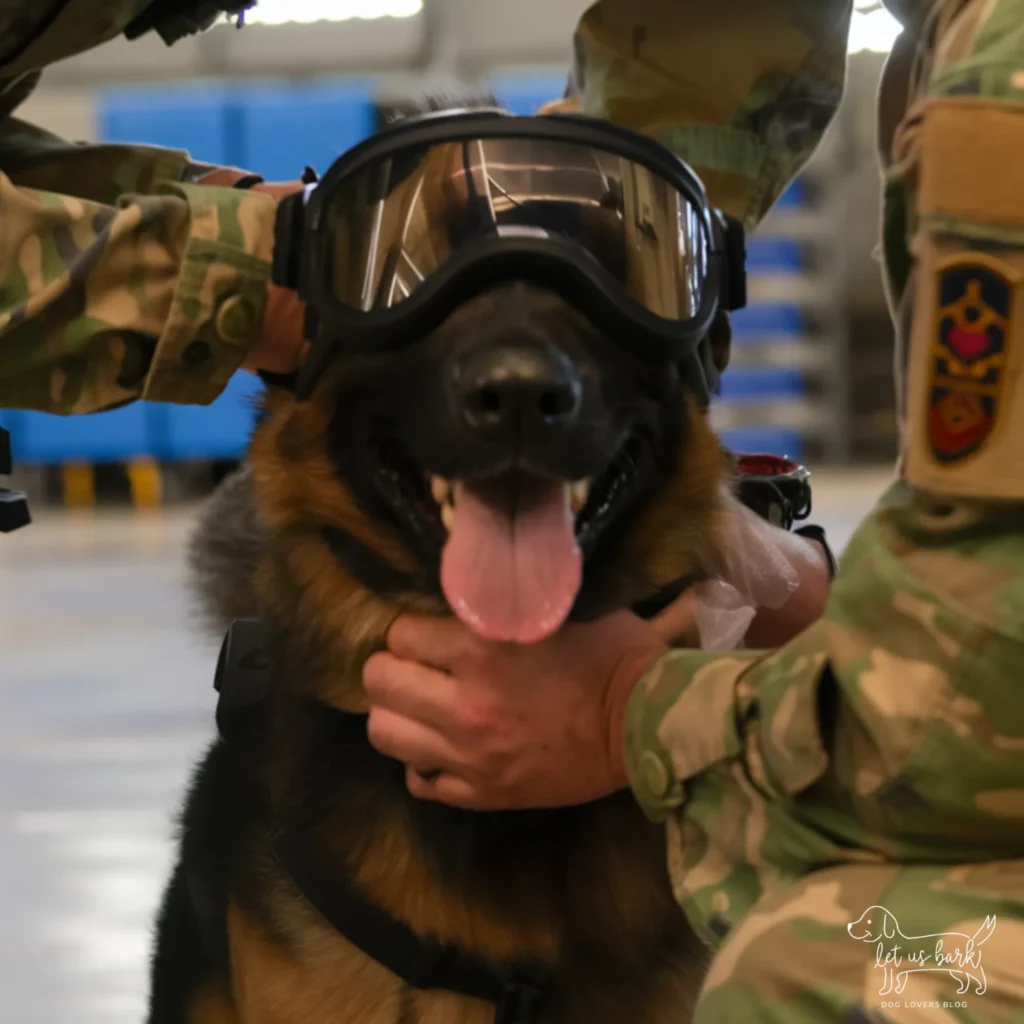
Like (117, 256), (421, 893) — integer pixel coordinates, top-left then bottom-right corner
(627, 484), (1024, 943)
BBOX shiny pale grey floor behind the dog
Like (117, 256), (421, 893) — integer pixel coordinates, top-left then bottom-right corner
(0, 472), (887, 1024)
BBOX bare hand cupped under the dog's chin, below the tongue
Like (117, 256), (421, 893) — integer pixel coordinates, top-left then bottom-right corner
(362, 611), (668, 810)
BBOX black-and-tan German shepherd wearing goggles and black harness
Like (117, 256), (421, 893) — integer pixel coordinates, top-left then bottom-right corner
(148, 101), (729, 1024)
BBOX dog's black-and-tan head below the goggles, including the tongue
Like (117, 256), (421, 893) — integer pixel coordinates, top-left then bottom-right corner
(209, 105), (729, 704)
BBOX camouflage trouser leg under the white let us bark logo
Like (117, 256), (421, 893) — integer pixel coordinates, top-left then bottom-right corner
(694, 860), (1024, 1024)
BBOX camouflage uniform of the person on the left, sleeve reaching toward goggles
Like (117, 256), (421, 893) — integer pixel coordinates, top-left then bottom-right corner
(0, 0), (275, 413)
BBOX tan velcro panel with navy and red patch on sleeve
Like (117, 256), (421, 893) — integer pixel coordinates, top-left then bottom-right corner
(904, 97), (1024, 501)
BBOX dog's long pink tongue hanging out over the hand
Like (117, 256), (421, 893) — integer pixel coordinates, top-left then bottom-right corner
(441, 478), (583, 643)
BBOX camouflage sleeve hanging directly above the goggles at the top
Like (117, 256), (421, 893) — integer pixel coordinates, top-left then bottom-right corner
(572, 0), (853, 228)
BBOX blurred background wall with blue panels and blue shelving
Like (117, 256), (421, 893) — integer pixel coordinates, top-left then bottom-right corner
(6, 0), (895, 505)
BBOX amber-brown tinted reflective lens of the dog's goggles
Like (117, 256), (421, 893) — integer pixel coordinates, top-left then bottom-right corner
(324, 137), (712, 322)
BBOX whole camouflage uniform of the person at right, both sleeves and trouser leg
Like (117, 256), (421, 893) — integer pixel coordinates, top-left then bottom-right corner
(577, 0), (1024, 1024)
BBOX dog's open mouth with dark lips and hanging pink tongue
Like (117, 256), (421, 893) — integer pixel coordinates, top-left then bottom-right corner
(380, 436), (650, 643)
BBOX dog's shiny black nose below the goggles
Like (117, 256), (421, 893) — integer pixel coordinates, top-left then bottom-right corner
(457, 345), (583, 435)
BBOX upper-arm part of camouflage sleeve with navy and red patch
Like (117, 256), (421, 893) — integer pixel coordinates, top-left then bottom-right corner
(886, 0), (1024, 501)
